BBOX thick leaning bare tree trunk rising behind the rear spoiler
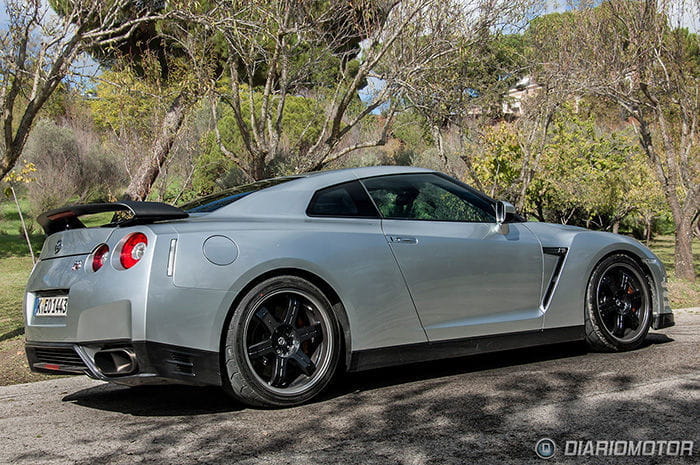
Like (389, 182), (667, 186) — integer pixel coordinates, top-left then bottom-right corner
(124, 93), (191, 200)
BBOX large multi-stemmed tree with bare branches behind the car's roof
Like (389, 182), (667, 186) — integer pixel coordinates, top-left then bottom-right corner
(192, 0), (508, 179)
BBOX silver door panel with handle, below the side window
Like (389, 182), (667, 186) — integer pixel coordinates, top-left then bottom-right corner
(382, 219), (543, 341)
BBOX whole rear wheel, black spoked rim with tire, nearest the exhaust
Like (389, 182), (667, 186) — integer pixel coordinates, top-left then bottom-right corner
(223, 276), (341, 407)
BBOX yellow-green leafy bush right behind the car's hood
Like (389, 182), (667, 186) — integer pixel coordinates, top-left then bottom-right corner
(528, 102), (658, 232)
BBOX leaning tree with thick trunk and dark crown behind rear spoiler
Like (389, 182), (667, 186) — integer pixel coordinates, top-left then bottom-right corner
(52, 0), (227, 200)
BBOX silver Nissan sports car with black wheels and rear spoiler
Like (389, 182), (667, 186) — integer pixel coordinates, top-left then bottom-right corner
(24, 167), (673, 406)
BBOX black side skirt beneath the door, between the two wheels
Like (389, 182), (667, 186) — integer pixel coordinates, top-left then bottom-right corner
(348, 326), (585, 371)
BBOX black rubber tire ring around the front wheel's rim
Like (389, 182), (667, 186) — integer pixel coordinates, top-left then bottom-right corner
(585, 254), (654, 352)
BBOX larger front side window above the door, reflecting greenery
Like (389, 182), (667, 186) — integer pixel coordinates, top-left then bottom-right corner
(362, 174), (496, 223)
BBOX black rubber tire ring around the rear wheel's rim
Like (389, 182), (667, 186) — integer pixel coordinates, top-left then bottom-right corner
(224, 276), (341, 407)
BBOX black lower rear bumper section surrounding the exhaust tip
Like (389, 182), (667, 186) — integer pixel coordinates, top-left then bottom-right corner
(25, 341), (221, 386)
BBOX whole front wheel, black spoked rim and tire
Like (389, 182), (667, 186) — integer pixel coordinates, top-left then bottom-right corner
(585, 254), (652, 352)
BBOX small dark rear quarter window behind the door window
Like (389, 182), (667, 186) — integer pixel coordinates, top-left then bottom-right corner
(306, 181), (378, 218)
